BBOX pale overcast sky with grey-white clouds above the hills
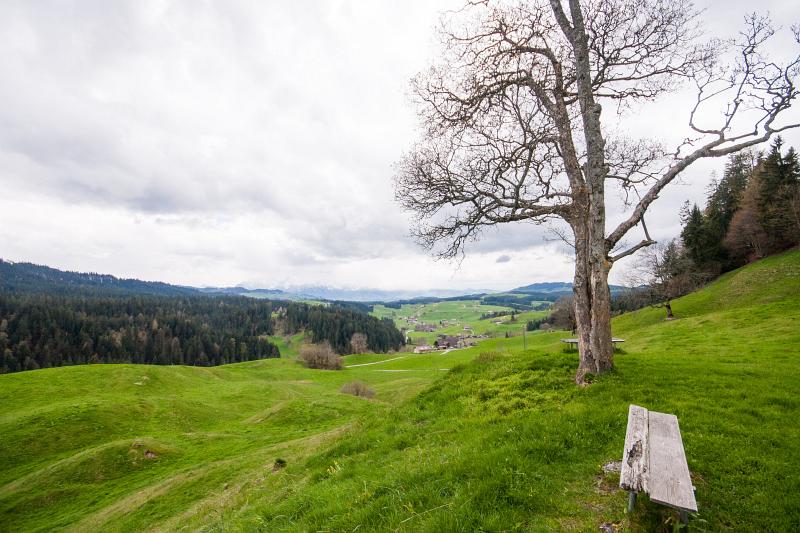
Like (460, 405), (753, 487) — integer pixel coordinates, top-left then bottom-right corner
(0, 0), (800, 290)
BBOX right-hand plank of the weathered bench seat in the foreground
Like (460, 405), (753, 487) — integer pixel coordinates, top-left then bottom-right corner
(648, 411), (697, 512)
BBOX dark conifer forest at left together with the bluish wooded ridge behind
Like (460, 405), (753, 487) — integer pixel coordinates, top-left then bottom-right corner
(0, 261), (404, 373)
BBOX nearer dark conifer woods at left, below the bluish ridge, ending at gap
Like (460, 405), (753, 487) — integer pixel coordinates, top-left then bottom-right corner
(0, 294), (280, 372)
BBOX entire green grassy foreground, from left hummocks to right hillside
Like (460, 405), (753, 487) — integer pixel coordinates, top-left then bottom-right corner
(0, 252), (800, 531)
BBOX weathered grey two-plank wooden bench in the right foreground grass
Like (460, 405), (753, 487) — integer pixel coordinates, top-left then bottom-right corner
(619, 405), (697, 524)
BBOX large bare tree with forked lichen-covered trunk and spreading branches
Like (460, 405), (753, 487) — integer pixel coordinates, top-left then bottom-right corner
(395, 0), (799, 383)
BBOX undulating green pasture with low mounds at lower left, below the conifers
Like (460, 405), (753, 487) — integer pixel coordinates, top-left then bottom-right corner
(0, 360), (442, 531)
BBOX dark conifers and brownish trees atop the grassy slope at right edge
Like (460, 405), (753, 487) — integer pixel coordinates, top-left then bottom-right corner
(612, 137), (800, 316)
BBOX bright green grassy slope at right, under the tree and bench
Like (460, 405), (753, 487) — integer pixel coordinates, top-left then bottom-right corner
(231, 252), (800, 531)
